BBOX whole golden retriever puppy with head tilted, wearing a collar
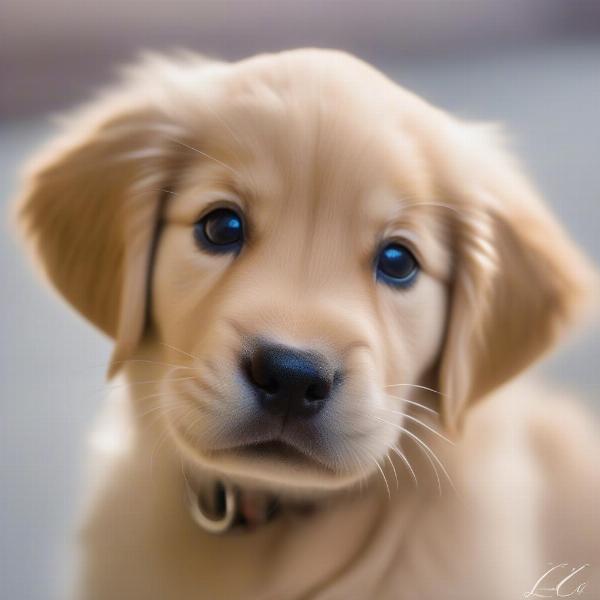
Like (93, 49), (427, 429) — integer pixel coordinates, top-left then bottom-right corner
(14, 50), (600, 600)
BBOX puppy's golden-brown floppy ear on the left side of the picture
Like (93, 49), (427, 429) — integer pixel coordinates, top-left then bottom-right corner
(18, 87), (180, 373)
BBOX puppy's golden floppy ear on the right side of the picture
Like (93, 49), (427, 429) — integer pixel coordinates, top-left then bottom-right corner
(439, 125), (596, 430)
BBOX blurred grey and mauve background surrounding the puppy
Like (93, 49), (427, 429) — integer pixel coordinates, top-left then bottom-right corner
(0, 0), (600, 600)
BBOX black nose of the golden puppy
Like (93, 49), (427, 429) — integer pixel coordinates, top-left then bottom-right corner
(247, 344), (334, 417)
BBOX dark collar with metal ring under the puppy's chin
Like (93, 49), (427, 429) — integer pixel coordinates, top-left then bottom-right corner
(186, 479), (315, 534)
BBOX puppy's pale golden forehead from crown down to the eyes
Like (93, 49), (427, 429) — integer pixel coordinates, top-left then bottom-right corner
(167, 56), (444, 276)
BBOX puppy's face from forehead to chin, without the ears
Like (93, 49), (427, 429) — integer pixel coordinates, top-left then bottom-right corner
(152, 71), (450, 492)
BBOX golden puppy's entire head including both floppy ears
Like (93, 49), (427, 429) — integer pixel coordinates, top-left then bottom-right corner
(21, 50), (587, 488)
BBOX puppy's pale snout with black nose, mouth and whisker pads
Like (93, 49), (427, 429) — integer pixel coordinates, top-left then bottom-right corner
(165, 311), (397, 489)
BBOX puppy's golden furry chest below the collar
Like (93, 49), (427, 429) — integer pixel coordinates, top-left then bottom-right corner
(83, 482), (528, 600)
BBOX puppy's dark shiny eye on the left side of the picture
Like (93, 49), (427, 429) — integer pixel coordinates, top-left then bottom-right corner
(194, 208), (244, 253)
